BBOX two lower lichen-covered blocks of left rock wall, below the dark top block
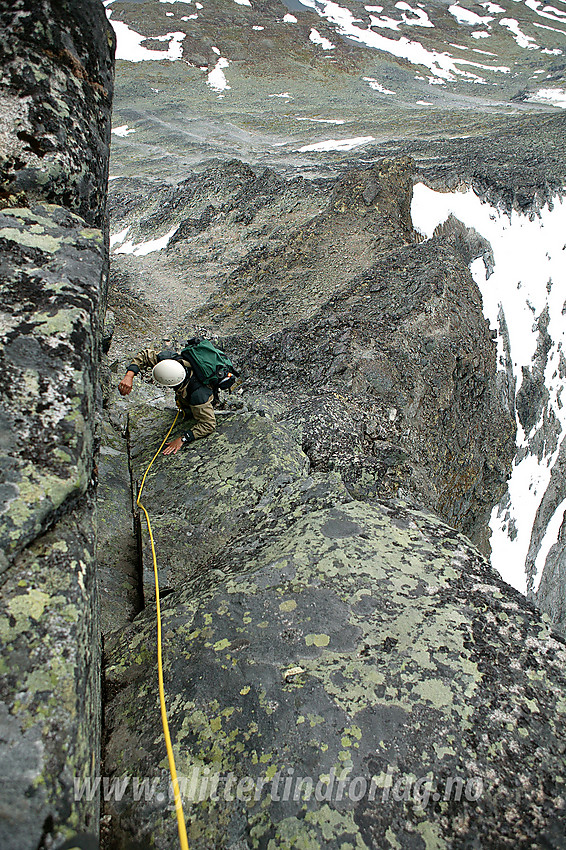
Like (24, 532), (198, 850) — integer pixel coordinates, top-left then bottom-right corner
(0, 197), (106, 850)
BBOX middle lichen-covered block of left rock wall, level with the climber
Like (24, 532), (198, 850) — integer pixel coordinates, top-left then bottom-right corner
(0, 204), (104, 572)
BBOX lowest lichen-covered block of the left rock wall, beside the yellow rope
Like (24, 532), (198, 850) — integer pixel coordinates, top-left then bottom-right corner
(0, 498), (100, 850)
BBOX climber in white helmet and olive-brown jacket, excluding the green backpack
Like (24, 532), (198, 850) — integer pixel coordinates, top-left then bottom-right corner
(118, 348), (216, 455)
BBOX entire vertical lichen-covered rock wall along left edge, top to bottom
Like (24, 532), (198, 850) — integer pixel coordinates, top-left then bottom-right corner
(0, 2), (114, 850)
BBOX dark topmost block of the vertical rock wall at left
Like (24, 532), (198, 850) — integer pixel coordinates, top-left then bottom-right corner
(0, 0), (115, 228)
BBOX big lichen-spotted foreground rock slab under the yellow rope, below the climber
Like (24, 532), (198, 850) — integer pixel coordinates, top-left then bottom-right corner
(105, 403), (566, 850)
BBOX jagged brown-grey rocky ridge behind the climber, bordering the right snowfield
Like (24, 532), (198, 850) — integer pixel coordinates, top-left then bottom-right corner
(106, 159), (514, 552)
